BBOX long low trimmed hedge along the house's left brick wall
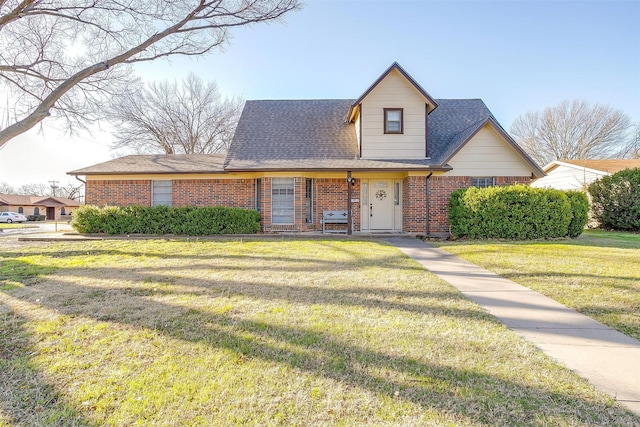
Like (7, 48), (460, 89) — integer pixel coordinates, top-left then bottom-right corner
(71, 206), (260, 236)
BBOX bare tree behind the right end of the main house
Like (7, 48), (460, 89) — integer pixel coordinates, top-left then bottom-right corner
(510, 100), (631, 165)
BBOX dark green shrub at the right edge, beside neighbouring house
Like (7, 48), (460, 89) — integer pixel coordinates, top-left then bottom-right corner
(589, 168), (640, 231)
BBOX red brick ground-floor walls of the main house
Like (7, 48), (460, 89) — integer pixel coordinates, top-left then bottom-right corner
(86, 176), (530, 234)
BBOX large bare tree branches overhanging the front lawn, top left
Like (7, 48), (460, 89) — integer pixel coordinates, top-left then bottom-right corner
(0, 0), (300, 147)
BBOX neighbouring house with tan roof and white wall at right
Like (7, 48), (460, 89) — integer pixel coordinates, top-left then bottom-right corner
(531, 159), (640, 190)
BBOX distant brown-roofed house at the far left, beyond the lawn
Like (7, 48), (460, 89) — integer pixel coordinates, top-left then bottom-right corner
(0, 194), (80, 220)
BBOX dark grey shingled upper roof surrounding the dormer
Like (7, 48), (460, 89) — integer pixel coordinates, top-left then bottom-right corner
(224, 99), (541, 172)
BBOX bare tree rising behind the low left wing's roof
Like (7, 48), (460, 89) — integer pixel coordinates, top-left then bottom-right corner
(108, 74), (244, 154)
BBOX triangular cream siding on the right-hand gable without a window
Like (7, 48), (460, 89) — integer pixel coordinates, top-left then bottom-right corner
(447, 125), (532, 176)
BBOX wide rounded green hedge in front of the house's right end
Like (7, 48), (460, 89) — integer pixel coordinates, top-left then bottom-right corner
(449, 185), (588, 240)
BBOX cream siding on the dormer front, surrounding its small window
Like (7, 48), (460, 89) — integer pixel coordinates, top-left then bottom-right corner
(361, 70), (426, 159)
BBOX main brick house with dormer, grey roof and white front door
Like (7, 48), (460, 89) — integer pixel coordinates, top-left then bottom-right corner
(69, 63), (544, 235)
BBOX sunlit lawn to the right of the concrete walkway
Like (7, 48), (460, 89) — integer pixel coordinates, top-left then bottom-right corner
(439, 230), (640, 340)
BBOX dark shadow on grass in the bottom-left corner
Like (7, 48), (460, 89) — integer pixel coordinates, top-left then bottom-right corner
(0, 302), (94, 426)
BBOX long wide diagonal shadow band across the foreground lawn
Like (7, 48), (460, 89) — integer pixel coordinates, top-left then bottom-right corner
(2, 270), (640, 425)
